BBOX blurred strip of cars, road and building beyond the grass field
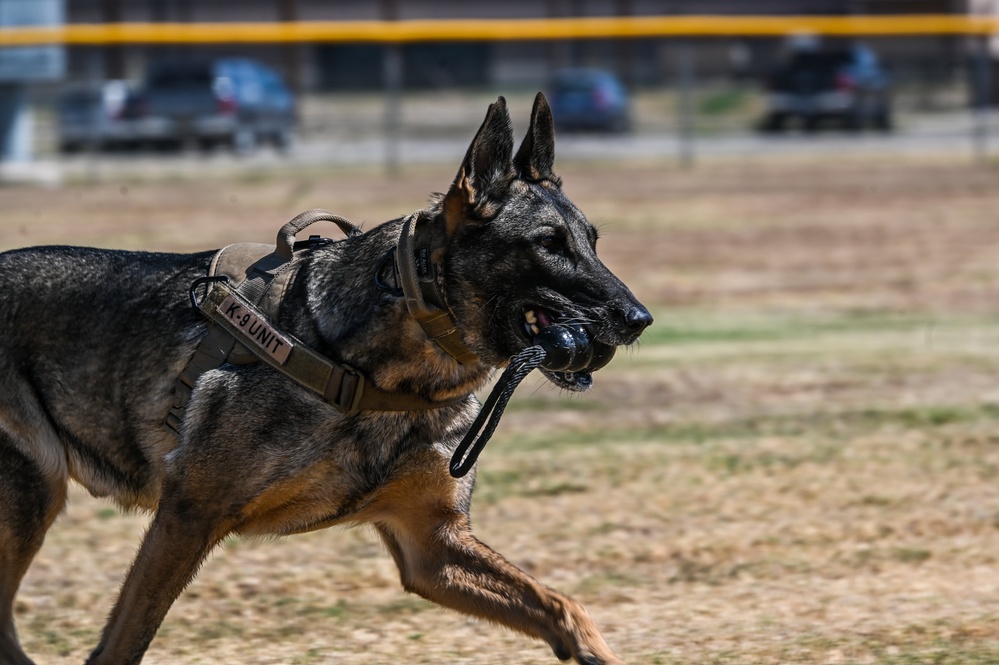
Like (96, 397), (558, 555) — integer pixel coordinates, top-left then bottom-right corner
(0, 0), (999, 179)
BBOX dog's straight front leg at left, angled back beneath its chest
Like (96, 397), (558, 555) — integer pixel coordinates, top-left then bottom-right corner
(87, 482), (228, 665)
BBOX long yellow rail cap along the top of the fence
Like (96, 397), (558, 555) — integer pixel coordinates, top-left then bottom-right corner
(0, 14), (999, 46)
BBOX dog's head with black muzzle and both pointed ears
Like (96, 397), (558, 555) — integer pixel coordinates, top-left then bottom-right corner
(434, 93), (652, 391)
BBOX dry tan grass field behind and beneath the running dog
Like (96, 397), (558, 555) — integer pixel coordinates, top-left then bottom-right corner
(0, 156), (999, 665)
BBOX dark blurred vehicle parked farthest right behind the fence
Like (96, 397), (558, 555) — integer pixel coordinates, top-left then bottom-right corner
(763, 44), (892, 131)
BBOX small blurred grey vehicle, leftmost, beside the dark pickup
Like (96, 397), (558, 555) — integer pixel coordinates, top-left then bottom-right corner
(56, 81), (135, 153)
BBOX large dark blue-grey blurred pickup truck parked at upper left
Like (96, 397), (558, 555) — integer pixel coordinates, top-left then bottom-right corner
(136, 58), (295, 153)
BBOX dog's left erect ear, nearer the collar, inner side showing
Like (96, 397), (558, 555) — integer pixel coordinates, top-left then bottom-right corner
(444, 97), (517, 235)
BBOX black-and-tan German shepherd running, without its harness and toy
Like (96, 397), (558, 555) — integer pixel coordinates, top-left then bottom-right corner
(0, 94), (652, 665)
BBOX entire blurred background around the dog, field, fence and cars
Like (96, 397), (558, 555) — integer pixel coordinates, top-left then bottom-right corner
(0, 0), (999, 665)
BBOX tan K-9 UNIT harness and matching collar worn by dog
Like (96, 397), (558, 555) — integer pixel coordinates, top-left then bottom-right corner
(165, 209), (475, 436)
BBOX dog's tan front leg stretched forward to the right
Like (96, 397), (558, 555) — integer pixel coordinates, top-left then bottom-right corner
(377, 508), (622, 665)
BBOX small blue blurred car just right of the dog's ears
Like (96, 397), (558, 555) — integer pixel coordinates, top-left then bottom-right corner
(548, 69), (631, 132)
